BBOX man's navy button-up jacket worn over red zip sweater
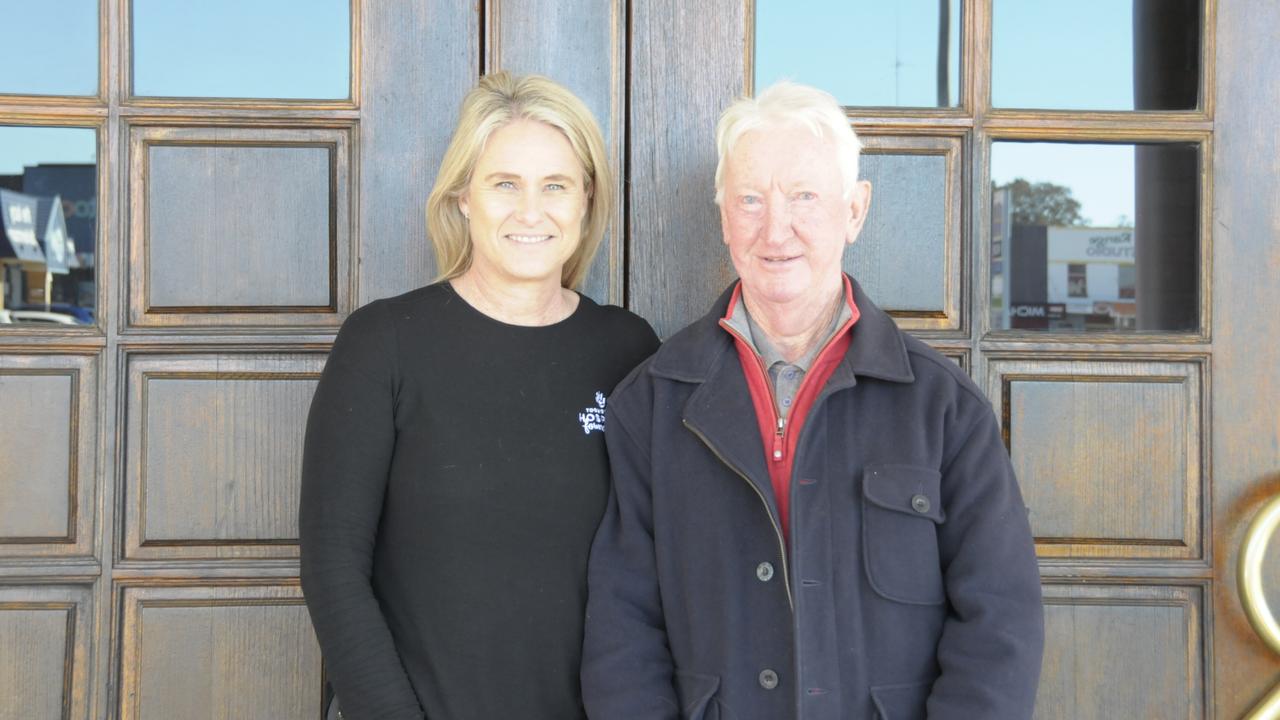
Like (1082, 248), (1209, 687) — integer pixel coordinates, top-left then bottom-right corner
(582, 278), (1043, 720)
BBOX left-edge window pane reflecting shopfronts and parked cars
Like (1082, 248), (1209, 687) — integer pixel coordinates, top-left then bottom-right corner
(0, 127), (97, 327)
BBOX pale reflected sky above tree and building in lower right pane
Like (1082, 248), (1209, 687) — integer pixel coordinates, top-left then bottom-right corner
(991, 142), (1134, 225)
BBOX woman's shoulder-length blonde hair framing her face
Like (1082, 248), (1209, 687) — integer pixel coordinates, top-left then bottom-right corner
(426, 72), (614, 287)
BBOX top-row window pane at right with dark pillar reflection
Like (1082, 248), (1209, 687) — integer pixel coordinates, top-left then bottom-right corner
(991, 0), (1201, 110)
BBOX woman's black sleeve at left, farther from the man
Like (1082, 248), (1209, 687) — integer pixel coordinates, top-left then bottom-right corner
(298, 304), (422, 720)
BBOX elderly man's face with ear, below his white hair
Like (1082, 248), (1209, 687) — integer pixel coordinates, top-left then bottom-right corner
(721, 124), (870, 315)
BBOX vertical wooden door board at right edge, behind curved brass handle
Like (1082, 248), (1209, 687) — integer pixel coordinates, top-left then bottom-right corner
(1210, 1), (1280, 717)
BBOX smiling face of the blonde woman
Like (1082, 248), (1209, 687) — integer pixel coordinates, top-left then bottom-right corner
(458, 120), (588, 287)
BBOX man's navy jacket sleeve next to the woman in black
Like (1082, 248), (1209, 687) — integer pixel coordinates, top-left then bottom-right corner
(582, 365), (680, 720)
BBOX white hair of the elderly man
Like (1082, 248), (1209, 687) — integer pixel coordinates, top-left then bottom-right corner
(716, 81), (863, 205)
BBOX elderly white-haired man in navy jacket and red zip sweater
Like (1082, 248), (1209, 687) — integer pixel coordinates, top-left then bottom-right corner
(582, 83), (1043, 720)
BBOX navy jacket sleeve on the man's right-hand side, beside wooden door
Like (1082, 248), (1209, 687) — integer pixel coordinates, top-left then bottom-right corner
(928, 396), (1044, 720)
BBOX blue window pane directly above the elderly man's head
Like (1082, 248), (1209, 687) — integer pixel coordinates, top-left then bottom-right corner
(754, 0), (960, 108)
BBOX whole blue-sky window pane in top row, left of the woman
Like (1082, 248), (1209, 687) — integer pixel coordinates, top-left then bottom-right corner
(132, 0), (351, 100)
